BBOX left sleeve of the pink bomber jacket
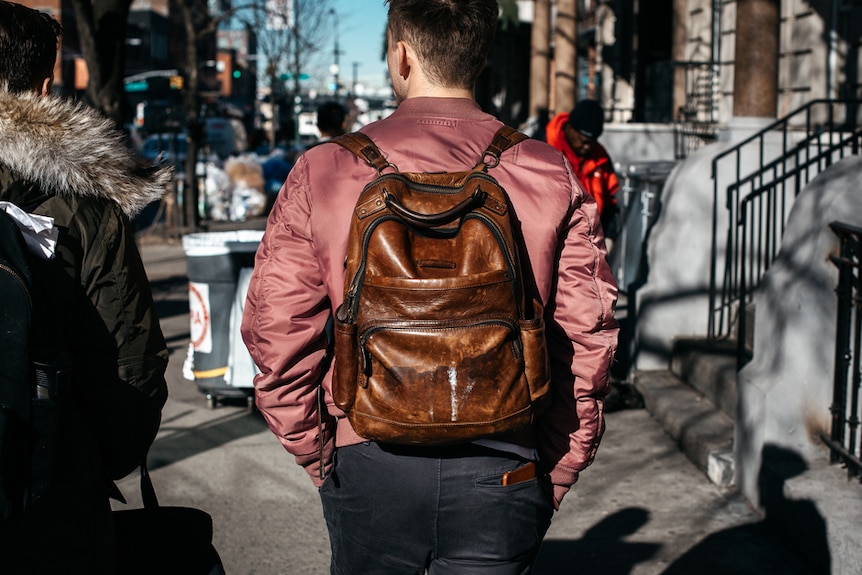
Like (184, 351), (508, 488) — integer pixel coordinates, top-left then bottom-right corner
(241, 157), (335, 486)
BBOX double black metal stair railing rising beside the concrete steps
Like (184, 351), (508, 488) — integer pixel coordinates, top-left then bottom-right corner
(708, 100), (862, 367)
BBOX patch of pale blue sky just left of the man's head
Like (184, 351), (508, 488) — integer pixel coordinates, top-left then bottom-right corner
(323, 0), (389, 93)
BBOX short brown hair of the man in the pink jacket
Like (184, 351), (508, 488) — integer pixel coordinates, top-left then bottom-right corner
(388, 0), (499, 89)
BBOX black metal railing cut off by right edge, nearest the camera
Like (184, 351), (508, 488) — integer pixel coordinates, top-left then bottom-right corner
(821, 222), (862, 481)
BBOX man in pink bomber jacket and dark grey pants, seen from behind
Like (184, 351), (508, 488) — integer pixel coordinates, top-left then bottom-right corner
(242, 0), (618, 575)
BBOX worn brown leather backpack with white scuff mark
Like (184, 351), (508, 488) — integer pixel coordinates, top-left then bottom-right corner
(333, 126), (549, 445)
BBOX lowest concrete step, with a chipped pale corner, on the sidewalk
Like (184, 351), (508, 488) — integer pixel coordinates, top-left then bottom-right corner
(633, 370), (734, 488)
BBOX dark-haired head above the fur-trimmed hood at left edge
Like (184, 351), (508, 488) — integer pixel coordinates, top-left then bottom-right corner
(0, 0), (63, 93)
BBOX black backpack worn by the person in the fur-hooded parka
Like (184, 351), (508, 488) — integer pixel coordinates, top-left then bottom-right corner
(0, 208), (72, 519)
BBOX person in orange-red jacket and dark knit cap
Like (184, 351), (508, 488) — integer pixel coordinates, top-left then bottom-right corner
(545, 100), (620, 239)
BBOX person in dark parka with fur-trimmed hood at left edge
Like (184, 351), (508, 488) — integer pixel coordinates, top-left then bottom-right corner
(0, 1), (171, 574)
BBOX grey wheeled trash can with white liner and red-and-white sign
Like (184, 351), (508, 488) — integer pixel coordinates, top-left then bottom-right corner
(183, 230), (263, 407)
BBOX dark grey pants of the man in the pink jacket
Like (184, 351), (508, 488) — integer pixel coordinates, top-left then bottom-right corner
(320, 443), (554, 575)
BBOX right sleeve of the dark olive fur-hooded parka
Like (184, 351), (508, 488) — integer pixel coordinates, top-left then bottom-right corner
(73, 202), (168, 479)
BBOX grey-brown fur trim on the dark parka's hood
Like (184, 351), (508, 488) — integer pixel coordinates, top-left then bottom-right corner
(0, 88), (173, 218)
